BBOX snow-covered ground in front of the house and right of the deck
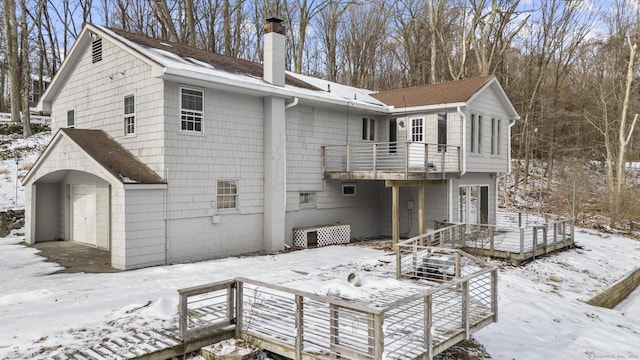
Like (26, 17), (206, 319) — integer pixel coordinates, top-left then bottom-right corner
(0, 225), (640, 359)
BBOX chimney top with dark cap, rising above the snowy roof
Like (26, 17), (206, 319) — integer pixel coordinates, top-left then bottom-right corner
(263, 17), (285, 86)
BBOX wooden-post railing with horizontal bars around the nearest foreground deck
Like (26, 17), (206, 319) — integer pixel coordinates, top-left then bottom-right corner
(179, 255), (497, 360)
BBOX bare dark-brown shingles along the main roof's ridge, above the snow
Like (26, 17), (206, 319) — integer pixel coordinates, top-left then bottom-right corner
(107, 28), (320, 90)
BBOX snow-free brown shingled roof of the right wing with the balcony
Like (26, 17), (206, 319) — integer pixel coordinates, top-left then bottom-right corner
(371, 75), (494, 108)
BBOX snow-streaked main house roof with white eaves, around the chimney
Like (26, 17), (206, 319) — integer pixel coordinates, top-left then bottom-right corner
(37, 23), (388, 113)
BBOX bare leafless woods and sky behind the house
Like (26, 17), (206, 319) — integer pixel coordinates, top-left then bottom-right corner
(0, 0), (640, 228)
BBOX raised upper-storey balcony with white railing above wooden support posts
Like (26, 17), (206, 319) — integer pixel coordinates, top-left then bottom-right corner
(322, 142), (460, 180)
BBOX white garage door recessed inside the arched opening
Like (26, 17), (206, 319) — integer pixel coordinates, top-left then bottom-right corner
(71, 185), (97, 245)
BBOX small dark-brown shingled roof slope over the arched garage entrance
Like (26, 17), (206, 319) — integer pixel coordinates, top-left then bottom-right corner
(60, 128), (165, 184)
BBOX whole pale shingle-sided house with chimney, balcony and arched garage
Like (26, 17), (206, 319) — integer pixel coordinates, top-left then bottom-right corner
(23, 19), (518, 269)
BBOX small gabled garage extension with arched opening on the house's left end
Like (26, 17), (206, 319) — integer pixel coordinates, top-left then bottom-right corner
(23, 129), (166, 270)
